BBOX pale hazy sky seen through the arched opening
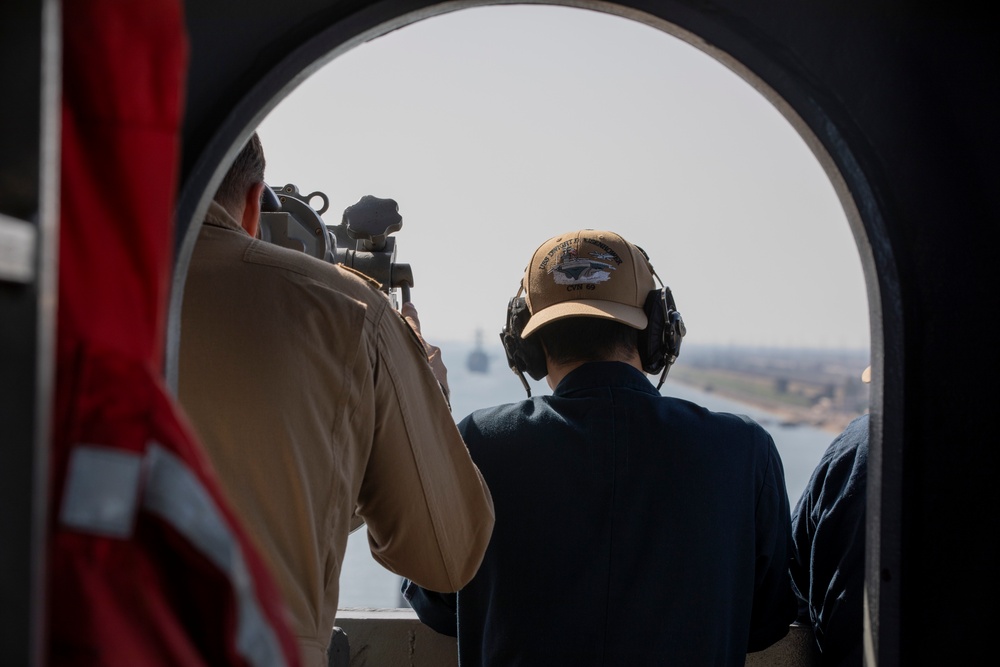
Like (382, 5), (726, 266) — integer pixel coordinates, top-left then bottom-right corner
(258, 5), (869, 349)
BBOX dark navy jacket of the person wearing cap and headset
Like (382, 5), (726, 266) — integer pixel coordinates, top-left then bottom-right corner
(403, 362), (796, 667)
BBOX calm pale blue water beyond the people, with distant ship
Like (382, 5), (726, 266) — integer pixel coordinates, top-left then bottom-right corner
(340, 340), (836, 607)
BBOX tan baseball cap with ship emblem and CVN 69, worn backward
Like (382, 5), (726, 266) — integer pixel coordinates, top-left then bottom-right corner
(521, 229), (656, 337)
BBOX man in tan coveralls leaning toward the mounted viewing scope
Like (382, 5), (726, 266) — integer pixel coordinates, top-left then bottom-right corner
(179, 134), (493, 667)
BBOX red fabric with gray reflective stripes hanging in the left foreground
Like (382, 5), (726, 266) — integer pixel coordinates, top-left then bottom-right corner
(44, 0), (299, 667)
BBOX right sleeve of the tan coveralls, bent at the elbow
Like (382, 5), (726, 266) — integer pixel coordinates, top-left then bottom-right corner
(358, 308), (493, 592)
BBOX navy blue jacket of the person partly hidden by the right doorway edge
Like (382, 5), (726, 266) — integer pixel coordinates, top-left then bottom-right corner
(792, 415), (868, 667)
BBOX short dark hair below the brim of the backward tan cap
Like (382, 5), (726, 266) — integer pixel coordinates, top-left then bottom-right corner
(536, 317), (639, 364)
